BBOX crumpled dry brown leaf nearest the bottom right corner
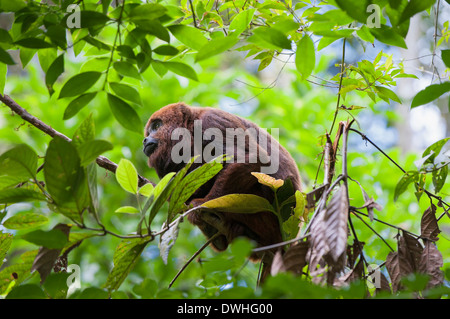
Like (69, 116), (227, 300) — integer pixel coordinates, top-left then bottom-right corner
(418, 240), (444, 289)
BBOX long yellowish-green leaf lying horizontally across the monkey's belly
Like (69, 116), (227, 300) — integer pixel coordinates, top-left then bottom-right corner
(201, 194), (275, 214)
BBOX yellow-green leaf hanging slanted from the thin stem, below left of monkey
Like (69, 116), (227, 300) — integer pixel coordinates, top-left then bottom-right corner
(105, 239), (148, 290)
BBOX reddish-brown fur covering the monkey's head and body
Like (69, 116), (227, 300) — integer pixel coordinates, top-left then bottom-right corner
(145, 103), (301, 258)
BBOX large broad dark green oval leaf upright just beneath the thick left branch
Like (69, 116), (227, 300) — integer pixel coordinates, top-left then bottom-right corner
(44, 136), (81, 204)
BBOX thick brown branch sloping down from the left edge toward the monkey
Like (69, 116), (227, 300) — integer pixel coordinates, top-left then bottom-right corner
(0, 94), (155, 187)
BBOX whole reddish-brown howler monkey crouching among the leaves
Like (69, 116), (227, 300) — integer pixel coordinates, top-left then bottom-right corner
(144, 103), (301, 259)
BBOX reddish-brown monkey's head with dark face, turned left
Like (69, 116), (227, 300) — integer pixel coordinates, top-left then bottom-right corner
(143, 103), (193, 178)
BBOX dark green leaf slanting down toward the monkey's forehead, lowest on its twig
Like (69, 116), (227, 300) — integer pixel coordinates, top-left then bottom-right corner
(108, 93), (143, 133)
